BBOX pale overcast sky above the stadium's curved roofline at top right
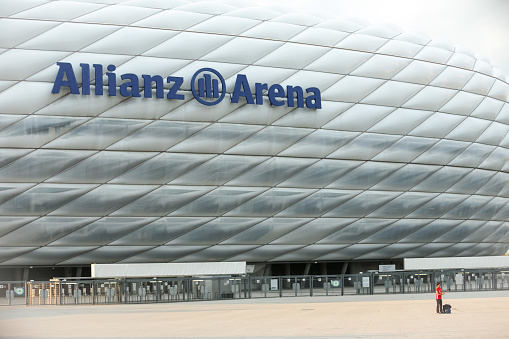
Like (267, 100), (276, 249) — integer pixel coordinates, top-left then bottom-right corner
(252, 0), (509, 75)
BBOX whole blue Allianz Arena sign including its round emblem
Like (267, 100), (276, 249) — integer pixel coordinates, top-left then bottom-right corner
(51, 62), (322, 109)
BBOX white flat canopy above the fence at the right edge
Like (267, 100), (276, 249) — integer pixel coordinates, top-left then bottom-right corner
(403, 256), (509, 271)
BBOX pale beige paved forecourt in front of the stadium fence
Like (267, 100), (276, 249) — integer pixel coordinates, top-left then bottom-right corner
(0, 291), (509, 339)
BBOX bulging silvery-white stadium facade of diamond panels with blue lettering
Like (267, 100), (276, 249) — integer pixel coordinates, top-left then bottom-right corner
(0, 0), (509, 278)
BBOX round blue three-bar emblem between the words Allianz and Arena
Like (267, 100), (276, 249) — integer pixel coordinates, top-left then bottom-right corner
(191, 68), (226, 106)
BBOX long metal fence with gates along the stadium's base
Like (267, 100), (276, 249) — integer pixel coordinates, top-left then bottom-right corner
(0, 269), (509, 305)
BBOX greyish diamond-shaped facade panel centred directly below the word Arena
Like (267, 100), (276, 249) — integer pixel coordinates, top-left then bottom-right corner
(226, 126), (313, 155)
